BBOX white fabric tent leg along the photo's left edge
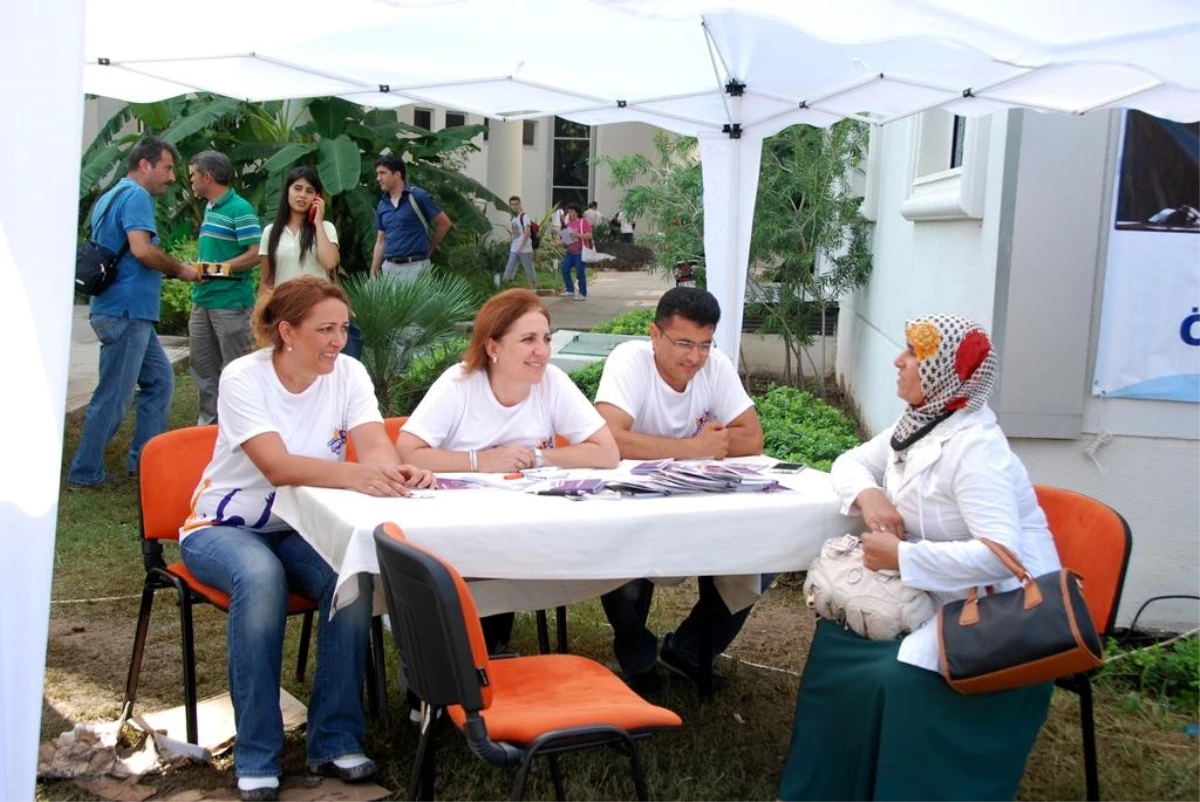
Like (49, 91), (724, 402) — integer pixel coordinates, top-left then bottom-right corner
(0, 0), (85, 800)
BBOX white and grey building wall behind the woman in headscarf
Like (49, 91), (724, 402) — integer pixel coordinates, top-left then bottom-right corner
(838, 112), (1200, 629)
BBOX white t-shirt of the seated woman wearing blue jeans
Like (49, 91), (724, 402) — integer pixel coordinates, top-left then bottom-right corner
(180, 348), (383, 539)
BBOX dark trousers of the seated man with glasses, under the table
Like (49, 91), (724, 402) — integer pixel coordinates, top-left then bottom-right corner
(600, 574), (774, 678)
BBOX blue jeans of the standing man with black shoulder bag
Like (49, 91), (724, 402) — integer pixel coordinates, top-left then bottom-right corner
(67, 315), (175, 485)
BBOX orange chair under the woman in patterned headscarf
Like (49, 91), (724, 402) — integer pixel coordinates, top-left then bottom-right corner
(1034, 485), (1133, 802)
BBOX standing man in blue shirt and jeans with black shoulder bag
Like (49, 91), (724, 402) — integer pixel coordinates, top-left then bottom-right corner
(67, 137), (199, 489)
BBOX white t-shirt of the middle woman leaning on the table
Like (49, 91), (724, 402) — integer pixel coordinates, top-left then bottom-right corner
(401, 363), (605, 451)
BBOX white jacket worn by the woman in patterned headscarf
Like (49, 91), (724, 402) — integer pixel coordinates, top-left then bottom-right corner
(832, 407), (1060, 671)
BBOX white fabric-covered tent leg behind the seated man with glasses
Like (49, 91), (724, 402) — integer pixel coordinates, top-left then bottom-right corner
(700, 133), (762, 367)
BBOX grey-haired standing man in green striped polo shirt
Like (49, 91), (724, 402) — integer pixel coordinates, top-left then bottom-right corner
(187, 150), (263, 426)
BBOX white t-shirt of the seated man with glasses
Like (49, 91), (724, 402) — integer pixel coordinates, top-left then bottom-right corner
(596, 340), (754, 439)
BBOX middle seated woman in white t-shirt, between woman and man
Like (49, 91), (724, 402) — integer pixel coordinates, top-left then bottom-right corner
(396, 289), (620, 652)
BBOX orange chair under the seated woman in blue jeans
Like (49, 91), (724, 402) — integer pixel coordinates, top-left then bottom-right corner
(122, 426), (318, 743)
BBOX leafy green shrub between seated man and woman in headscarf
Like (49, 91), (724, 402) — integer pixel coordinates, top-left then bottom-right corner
(755, 384), (859, 471)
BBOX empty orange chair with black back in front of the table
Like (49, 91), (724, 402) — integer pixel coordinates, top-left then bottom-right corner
(374, 523), (682, 802)
